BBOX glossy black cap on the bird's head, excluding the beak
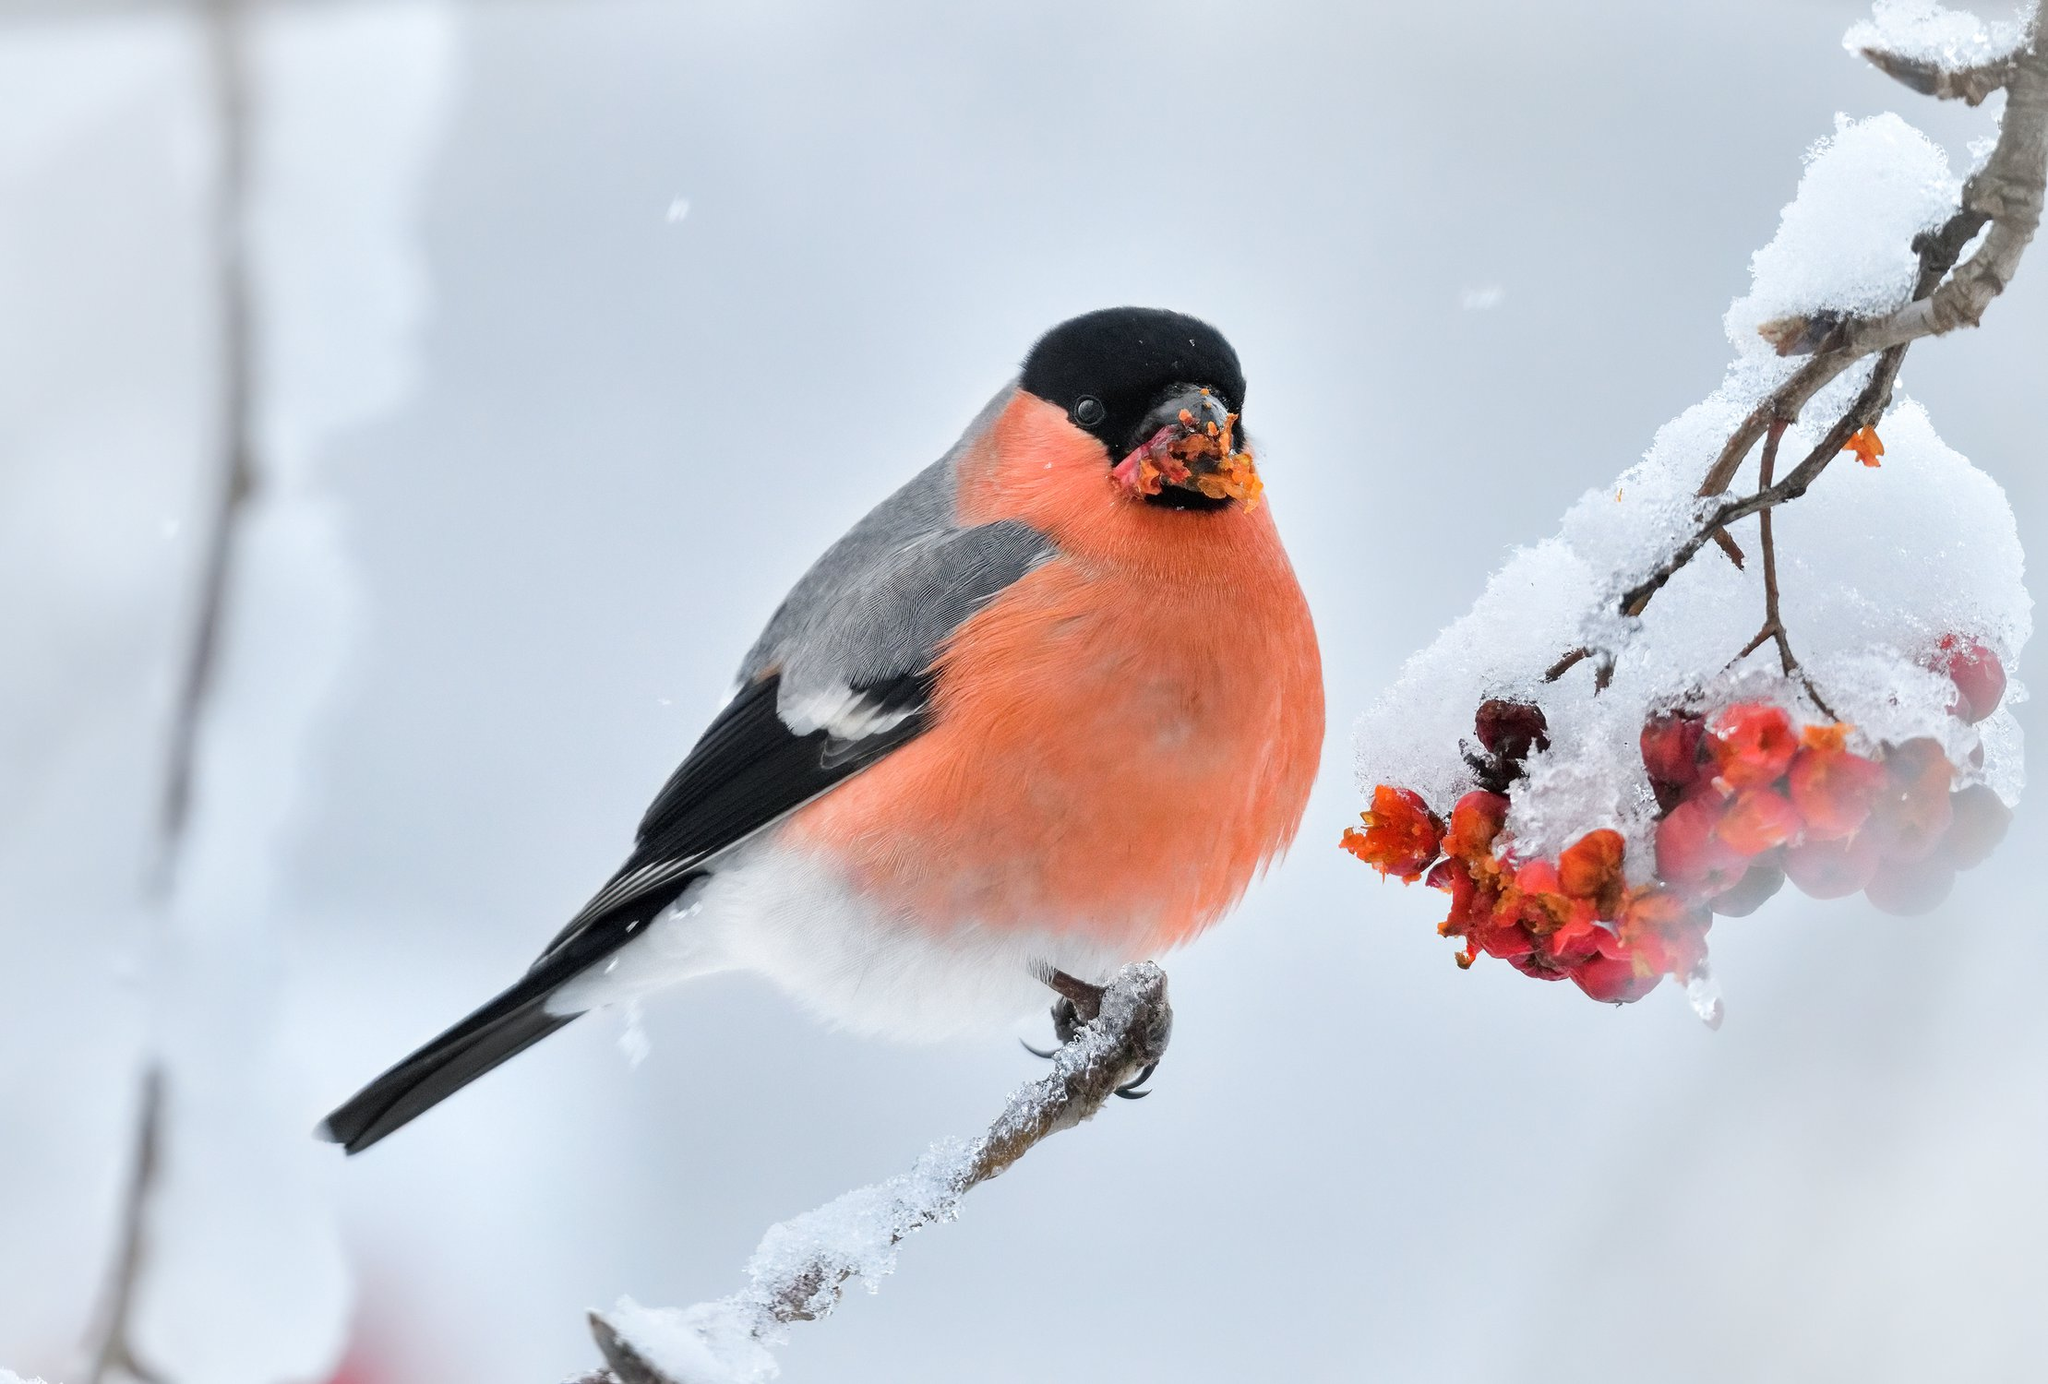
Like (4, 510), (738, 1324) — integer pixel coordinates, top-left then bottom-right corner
(1022, 307), (1245, 457)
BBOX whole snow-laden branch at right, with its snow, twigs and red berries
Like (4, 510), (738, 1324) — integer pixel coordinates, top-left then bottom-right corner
(1343, 2), (2048, 1013)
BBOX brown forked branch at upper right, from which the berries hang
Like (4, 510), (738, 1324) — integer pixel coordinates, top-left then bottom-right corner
(1620, 16), (2048, 616)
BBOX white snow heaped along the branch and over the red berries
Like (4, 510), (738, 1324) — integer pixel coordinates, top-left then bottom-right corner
(1356, 67), (2032, 882)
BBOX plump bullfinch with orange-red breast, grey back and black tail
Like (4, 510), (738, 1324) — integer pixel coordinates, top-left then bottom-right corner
(319, 307), (1323, 1153)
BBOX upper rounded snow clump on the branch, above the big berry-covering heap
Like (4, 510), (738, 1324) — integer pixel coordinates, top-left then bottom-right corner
(1724, 113), (1962, 354)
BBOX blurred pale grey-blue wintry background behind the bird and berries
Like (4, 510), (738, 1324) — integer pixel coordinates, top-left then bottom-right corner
(0, 0), (2048, 1384)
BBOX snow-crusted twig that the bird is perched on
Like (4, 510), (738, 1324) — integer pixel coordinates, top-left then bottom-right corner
(580, 962), (1174, 1384)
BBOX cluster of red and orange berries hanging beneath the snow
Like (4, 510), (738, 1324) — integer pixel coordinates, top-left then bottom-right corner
(1343, 637), (2011, 1003)
